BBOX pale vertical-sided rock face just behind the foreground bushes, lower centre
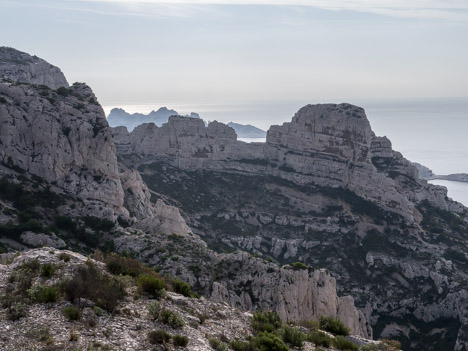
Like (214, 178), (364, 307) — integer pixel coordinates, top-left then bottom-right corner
(211, 253), (372, 337)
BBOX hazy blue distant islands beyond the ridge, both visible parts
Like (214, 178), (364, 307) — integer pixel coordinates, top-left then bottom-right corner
(107, 107), (266, 138)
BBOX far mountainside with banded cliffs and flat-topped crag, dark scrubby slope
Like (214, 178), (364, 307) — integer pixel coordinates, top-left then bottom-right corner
(114, 104), (468, 350)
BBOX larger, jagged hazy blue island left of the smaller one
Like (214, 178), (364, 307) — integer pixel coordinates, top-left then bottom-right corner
(107, 107), (200, 131)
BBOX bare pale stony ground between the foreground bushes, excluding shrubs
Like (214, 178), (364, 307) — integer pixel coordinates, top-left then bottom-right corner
(0, 248), (390, 351)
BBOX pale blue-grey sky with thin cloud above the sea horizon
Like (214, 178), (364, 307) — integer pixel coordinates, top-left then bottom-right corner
(0, 0), (468, 106)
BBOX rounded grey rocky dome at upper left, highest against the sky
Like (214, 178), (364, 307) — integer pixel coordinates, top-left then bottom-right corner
(0, 46), (68, 89)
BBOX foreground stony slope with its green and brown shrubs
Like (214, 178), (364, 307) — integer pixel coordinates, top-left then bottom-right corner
(0, 248), (397, 351)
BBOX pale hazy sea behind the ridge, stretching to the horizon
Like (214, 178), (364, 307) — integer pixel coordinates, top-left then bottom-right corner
(104, 97), (468, 206)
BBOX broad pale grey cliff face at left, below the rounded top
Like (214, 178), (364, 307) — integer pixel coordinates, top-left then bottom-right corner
(0, 83), (124, 213)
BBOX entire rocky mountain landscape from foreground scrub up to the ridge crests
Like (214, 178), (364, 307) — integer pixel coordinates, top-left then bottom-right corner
(0, 48), (468, 351)
